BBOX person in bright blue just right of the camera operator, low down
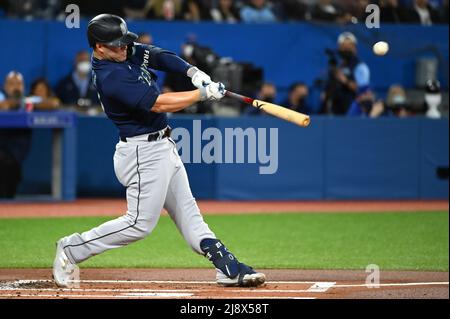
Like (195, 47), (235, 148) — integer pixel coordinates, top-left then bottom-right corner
(347, 86), (385, 118)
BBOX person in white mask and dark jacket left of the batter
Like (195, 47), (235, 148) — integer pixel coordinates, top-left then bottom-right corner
(55, 50), (99, 111)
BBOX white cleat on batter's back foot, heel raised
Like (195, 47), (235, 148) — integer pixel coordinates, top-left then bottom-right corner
(53, 240), (80, 288)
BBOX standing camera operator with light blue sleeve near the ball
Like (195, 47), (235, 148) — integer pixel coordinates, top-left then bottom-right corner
(322, 32), (370, 115)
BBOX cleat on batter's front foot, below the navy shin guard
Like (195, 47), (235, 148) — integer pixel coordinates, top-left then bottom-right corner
(216, 263), (266, 287)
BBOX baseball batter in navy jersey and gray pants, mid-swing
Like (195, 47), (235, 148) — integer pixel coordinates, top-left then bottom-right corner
(53, 14), (266, 287)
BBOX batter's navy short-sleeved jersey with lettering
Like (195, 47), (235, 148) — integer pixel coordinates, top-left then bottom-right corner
(92, 43), (191, 137)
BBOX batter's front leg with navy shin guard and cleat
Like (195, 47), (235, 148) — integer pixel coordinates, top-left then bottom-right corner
(164, 140), (266, 286)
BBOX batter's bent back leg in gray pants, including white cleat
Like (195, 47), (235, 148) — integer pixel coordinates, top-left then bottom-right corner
(53, 140), (175, 287)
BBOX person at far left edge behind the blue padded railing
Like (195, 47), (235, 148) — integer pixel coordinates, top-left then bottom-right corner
(0, 71), (31, 198)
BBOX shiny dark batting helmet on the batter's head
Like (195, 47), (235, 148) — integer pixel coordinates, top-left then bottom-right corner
(87, 13), (138, 48)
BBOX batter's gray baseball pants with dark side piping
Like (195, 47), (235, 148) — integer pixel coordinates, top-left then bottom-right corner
(62, 135), (216, 263)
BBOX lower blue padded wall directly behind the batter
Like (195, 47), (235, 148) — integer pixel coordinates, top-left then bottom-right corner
(20, 116), (449, 200)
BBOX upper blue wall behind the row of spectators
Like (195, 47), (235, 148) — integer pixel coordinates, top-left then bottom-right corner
(0, 19), (449, 95)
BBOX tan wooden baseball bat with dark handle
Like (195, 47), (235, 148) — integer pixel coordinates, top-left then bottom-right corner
(225, 91), (311, 127)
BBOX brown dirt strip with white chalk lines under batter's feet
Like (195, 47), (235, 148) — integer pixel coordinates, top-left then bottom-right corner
(0, 269), (448, 299)
